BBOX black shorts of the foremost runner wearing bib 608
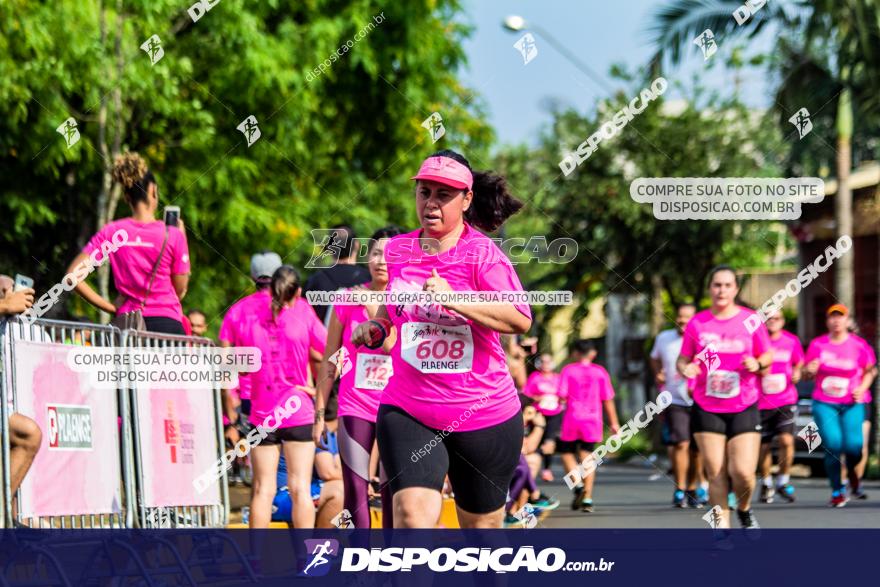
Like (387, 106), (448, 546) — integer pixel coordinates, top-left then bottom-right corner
(376, 404), (522, 514)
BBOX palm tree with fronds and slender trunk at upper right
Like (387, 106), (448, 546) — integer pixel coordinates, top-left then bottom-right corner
(651, 0), (880, 307)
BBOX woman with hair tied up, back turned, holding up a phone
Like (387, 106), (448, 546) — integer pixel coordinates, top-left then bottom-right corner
(68, 153), (190, 334)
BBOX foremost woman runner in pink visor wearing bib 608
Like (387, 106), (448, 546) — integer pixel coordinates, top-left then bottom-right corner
(352, 150), (532, 528)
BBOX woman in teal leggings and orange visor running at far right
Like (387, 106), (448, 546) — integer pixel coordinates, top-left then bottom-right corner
(805, 304), (876, 507)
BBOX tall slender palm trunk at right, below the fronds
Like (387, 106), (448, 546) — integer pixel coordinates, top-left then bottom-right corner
(834, 89), (856, 313)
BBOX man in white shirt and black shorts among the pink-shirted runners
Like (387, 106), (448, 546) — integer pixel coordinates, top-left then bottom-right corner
(651, 304), (707, 508)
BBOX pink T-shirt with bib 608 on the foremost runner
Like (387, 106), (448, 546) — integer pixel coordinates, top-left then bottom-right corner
(382, 224), (531, 431)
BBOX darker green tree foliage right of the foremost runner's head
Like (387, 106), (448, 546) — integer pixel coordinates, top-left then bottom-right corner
(498, 73), (780, 328)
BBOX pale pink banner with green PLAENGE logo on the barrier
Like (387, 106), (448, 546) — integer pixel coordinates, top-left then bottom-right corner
(13, 340), (122, 518)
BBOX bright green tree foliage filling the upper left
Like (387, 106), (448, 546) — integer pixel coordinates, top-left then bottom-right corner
(0, 0), (492, 330)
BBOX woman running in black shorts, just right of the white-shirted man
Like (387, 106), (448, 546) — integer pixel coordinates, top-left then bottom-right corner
(676, 265), (773, 530)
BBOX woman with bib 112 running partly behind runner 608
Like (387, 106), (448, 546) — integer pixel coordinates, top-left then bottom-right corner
(312, 226), (402, 528)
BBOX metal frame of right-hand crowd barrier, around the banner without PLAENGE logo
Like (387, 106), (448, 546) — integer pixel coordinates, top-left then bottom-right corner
(119, 330), (229, 528)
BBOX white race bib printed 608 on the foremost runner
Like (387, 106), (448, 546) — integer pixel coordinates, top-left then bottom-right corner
(400, 322), (474, 373)
